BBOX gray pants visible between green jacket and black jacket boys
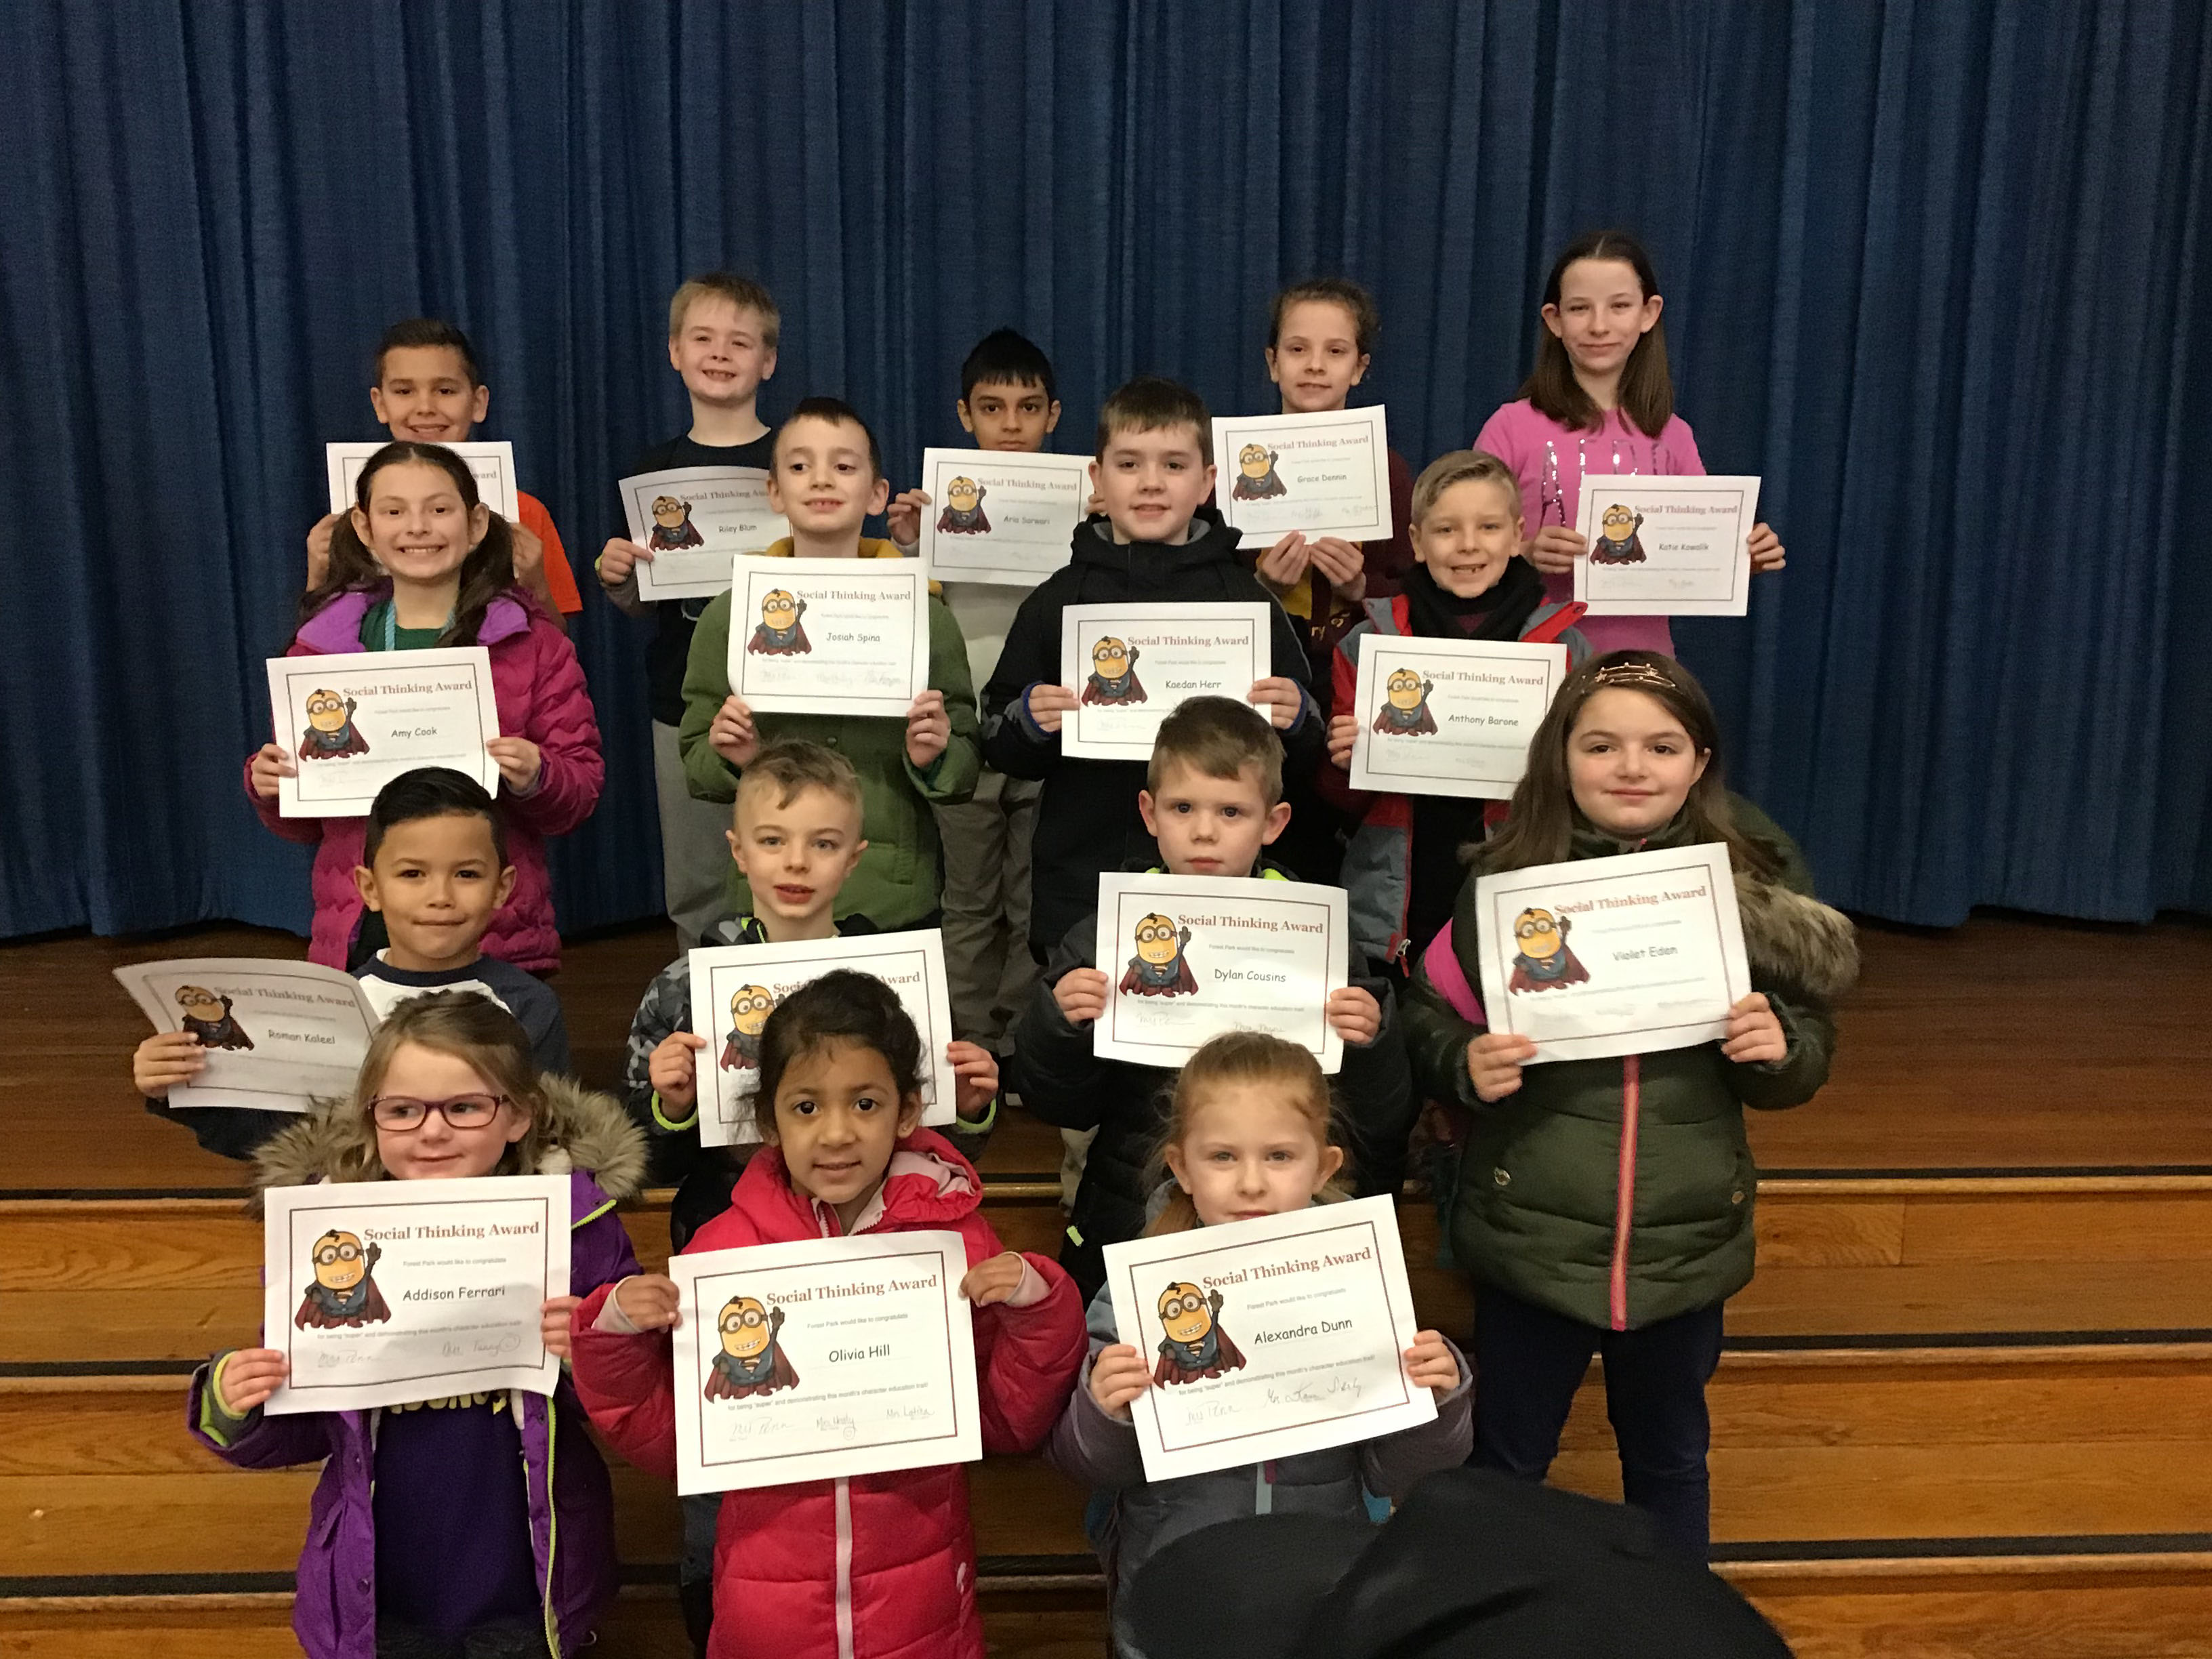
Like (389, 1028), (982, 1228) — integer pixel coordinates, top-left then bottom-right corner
(936, 772), (1044, 1048)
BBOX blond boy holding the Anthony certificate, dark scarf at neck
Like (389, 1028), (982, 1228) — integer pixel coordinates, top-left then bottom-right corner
(1321, 449), (1591, 973)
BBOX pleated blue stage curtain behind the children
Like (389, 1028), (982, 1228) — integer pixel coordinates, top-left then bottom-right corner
(0, 0), (2212, 936)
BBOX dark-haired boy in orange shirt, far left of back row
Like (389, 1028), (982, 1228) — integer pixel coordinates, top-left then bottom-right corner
(308, 316), (584, 628)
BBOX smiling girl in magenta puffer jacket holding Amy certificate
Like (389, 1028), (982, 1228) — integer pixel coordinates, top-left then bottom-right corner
(245, 443), (606, 973)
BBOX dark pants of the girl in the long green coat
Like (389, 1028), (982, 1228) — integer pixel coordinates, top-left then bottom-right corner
(1473, 1283), (1721, 1559)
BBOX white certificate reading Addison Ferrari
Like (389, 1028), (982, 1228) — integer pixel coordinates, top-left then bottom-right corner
(261, 1174), (569, 1414)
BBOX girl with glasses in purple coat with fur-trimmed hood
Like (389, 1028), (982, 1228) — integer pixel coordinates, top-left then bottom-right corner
(188, 991), (646, 1659)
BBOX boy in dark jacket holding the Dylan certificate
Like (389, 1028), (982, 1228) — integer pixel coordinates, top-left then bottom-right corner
(1006, 697), (1418, 1300)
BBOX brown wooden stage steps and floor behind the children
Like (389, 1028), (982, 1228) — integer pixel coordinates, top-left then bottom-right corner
(0, 918), (2212, 1659)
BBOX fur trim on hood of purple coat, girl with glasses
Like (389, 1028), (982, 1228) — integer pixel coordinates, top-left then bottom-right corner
(250, 1078), (646, 1212)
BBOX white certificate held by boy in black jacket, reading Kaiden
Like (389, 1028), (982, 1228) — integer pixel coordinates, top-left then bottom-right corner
(1059, 600), (1274, 761)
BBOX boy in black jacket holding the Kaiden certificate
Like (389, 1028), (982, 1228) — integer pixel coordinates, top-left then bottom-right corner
(982, 376), (1327, 962)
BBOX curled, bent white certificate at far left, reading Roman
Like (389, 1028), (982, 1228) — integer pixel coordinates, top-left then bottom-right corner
(115, 956), (378, 1113)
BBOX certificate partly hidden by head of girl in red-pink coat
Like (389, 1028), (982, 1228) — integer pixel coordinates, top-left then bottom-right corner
(690, 927), (958, 1146)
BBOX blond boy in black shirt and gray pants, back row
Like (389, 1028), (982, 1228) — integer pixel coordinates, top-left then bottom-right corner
(597, 270), (783, 949)
